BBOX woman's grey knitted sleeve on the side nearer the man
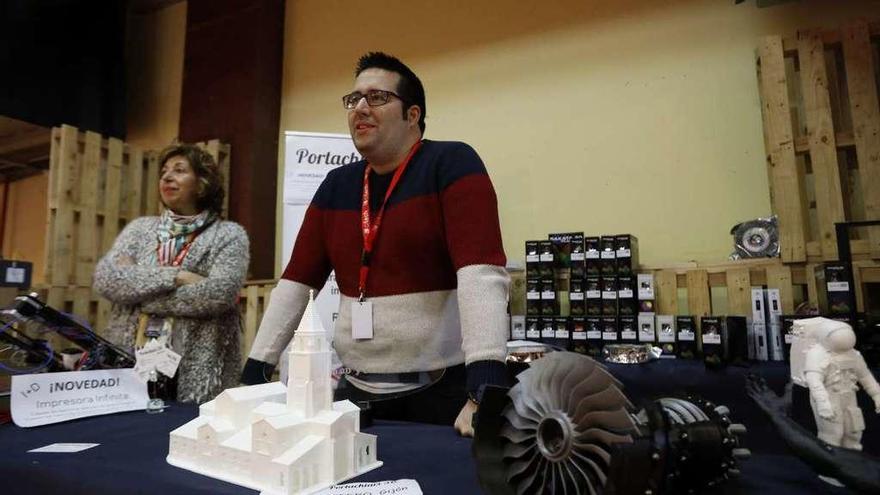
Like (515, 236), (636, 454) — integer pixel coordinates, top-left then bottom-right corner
(142, 222), (250, 318)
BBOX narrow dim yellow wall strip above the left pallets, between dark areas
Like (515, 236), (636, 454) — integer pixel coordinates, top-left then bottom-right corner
(126, 2), (186, 149)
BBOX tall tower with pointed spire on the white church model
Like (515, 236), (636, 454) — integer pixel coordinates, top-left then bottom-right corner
(287, 291), (333, 418)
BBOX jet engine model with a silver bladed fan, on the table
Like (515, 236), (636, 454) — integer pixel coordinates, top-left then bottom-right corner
(473, 352), (749, 495)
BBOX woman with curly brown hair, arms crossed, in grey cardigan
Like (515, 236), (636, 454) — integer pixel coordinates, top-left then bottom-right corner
(94, 144), (249, 403)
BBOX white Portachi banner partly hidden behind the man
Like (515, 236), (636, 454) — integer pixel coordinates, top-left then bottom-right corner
(281, 131), (361, 334)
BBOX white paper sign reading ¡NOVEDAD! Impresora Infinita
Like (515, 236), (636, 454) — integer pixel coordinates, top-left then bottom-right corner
(10, 368), (149, 428)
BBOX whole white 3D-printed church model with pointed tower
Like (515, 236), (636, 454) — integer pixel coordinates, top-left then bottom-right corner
(167, 292), (382, 495)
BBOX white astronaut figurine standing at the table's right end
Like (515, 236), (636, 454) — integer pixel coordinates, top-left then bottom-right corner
(803, 318), (880, 450)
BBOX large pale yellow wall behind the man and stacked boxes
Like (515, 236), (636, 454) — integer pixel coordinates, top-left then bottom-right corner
(277, 0), (880, 276)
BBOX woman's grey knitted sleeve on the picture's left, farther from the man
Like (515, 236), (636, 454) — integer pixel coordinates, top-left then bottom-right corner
(93, 217), (178, 305)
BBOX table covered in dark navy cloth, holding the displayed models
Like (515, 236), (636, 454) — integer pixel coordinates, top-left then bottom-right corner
(0, 361), (880, 495)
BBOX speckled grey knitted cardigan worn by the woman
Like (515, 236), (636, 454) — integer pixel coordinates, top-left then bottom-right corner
(94, 217), (249, 403)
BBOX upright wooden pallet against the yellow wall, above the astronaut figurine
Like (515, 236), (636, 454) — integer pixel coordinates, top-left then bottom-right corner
(758, 21), (880, 262)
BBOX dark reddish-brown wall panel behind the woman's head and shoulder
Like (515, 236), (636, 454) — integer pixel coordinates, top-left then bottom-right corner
(180, 0), (284, 278)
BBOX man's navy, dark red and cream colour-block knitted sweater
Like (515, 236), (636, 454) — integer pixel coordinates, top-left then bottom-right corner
(246, 141), (509, 389)
